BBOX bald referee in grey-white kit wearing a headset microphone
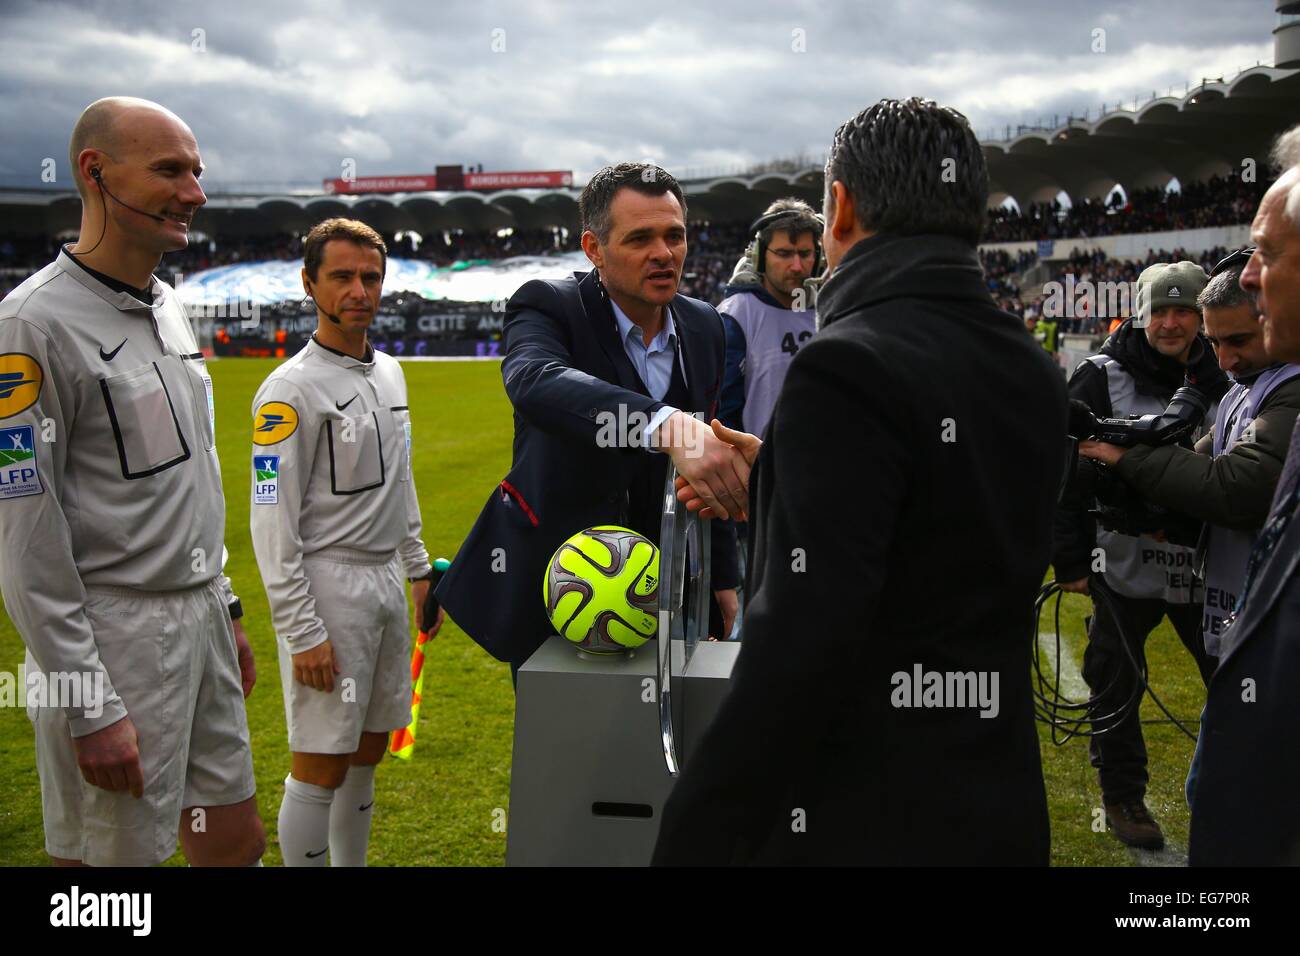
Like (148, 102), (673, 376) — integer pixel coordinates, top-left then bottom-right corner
(0, 98), (265, 866)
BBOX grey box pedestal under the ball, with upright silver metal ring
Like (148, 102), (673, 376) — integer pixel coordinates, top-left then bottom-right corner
(506, 467), (740, 866)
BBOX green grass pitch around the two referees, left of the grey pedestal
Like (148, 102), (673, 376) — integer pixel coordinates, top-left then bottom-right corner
(0, 359), (515, 866)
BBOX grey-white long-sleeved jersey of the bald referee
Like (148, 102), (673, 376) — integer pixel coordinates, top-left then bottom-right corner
(0, 251), (229, 736)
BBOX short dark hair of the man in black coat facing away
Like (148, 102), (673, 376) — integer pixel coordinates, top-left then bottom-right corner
(826, 96), (988, 245)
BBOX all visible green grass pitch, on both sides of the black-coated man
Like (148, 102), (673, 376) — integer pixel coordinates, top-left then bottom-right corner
(0, 359), (1204, 866)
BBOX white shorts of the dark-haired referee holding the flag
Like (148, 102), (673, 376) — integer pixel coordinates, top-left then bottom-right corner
(280, 548), (411, 753)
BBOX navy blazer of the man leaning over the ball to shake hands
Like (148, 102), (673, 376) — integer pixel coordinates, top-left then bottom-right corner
(437, 269), (737, 663)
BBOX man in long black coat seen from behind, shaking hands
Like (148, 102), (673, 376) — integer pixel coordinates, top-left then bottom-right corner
(654, 99), (1066, 865)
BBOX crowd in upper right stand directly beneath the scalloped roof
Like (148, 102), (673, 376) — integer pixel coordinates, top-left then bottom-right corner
(984, 176), (1270, 242)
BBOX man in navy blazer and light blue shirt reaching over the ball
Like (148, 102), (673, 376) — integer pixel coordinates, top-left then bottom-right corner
(437, 163), (749, 675)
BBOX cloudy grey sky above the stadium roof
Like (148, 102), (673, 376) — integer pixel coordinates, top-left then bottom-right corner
(0, 0), (1275, 191)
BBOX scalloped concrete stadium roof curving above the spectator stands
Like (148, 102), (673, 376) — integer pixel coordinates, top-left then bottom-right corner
(0, 66), (1300, 238)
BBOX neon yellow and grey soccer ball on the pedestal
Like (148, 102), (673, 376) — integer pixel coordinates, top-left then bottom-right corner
(542, 524), (659, 654)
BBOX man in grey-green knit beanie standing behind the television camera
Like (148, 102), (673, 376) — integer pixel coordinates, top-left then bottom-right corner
(1052, 261), (1227, 849)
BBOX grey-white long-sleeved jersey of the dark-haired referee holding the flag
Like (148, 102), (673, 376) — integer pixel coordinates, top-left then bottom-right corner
(250, 336), (430, 654)
